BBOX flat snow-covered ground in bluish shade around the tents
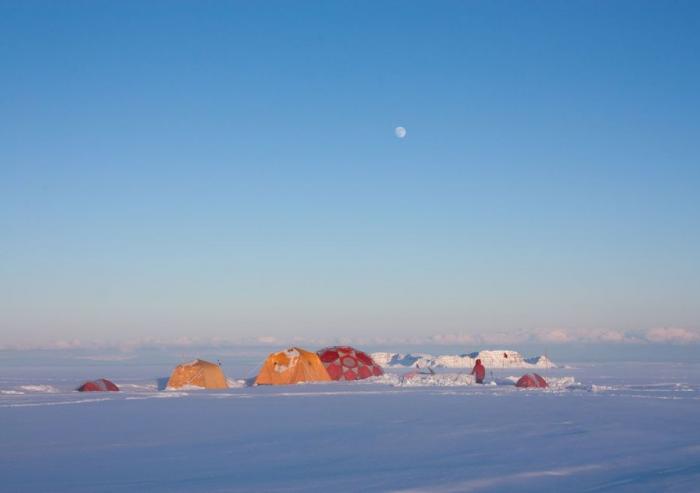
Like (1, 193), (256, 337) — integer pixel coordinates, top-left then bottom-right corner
(0, 352), (700, 492)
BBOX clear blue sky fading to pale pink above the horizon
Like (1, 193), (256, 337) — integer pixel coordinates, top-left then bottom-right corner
(0, 0), (700, 346)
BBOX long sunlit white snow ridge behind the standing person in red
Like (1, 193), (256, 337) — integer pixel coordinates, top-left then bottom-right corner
(372, 350), (556, 369)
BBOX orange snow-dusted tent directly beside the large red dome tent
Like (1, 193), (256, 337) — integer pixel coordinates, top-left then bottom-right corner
(255, 347), (331, 385)
